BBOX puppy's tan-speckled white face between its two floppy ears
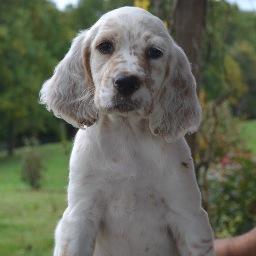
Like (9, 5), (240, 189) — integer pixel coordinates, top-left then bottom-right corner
(90, 10), (170, 115)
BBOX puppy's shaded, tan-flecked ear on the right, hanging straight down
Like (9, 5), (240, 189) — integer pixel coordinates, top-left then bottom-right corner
(149, 43), (201, 142)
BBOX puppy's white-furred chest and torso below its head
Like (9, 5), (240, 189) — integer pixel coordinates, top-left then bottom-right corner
(57, 116), (214, 256)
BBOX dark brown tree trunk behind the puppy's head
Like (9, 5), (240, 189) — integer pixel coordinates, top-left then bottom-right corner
(171, 0), (207, 157)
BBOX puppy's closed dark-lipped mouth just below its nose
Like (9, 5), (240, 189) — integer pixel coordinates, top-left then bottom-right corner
(106, 95), (141, 113)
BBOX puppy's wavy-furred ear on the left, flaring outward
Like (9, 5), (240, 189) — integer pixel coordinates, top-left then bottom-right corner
(40, 31), (97, 128)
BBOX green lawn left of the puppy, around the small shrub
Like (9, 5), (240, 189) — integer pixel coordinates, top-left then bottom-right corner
(0, 144), (69, 256)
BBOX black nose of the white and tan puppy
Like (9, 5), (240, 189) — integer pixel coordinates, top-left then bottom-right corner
(114, 76), (140, 96)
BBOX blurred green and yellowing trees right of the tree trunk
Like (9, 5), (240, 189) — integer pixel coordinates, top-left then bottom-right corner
(202, 1), (256, 108)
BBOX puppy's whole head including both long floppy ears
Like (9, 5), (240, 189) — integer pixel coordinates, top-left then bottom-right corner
(41, 7), (200, 139)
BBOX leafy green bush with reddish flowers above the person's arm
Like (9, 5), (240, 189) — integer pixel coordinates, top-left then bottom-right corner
(208, 152), (256, 237)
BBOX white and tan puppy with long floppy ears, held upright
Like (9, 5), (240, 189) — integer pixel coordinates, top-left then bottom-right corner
(40, 7), (214, 256)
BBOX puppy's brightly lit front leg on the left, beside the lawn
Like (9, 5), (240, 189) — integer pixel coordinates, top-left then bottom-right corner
(54, 200), (100, 256)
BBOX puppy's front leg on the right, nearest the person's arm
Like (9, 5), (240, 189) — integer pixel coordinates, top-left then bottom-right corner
(168, 159), (214, 256)
